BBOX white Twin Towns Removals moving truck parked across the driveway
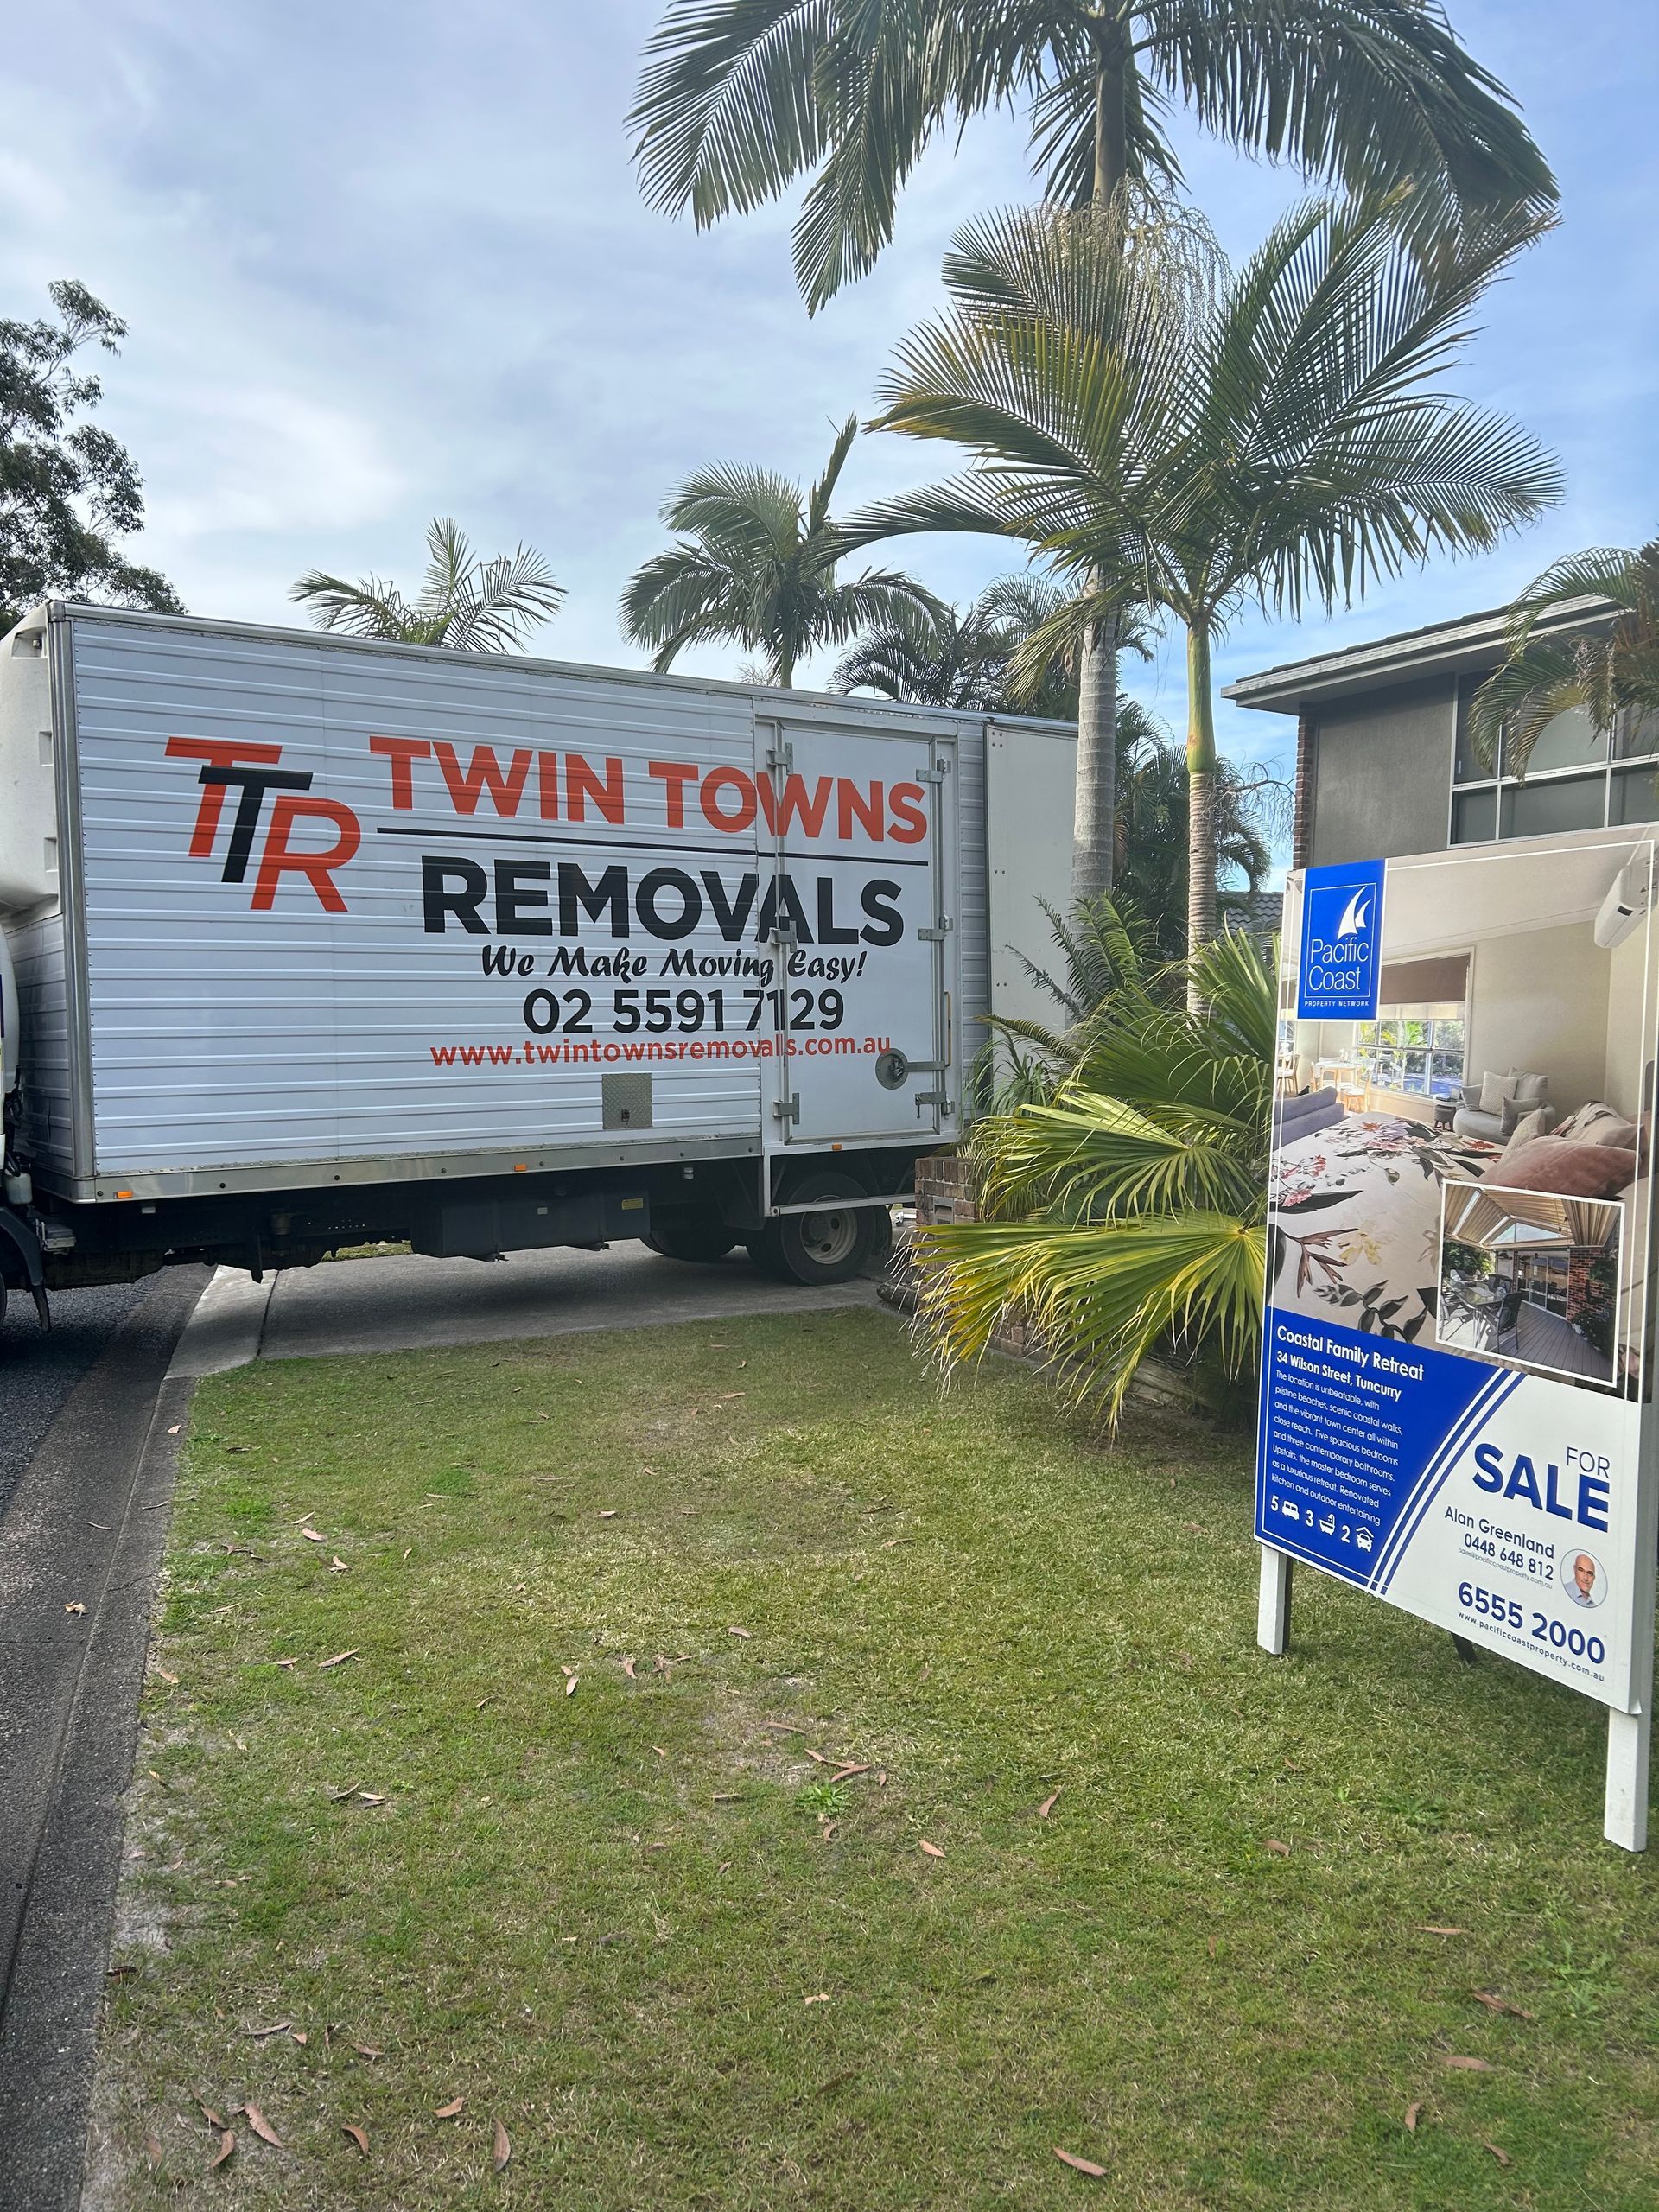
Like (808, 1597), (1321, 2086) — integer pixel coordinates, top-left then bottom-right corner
(0, 601), (1075, 1319)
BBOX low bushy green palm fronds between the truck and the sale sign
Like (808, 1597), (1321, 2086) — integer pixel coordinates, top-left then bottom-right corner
(916, 911), (1276, 1418)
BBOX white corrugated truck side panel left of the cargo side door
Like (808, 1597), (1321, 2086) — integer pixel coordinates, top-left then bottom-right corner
(75, 615), (759, 1173)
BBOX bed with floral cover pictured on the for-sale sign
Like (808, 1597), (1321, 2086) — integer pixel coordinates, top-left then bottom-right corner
(1268, 1113), (1504, 1343)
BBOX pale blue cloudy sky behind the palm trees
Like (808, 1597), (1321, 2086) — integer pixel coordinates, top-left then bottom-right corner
(0, 0), (1659, 871)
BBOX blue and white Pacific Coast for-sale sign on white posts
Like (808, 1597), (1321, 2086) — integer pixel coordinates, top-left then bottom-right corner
(1256, 830), (1659, 1847)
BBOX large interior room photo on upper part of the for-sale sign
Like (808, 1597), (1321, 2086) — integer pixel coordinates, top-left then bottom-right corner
(1268, 836), (1655, 1395)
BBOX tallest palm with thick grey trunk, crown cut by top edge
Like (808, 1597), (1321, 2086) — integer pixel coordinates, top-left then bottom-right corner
(631, 0), (1555, 898)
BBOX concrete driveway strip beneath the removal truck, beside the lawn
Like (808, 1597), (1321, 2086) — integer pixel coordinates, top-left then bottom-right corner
(173, 1243), (876, 1376)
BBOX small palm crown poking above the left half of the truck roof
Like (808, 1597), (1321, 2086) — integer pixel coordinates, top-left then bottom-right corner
(288, 522), (564, 652)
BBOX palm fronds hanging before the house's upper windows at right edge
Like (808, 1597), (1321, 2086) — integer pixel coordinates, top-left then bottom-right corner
(1469, 537), (1659, 777)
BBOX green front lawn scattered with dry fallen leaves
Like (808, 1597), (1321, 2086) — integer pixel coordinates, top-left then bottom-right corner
(104, 1310), (1659, 2212)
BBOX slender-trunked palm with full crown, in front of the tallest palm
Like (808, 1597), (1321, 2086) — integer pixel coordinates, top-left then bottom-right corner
(865, 194), (1560, 977)
